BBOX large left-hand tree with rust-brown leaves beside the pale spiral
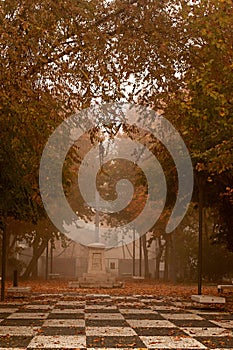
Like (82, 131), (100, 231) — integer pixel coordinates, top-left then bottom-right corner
(0, 0), (140, 278)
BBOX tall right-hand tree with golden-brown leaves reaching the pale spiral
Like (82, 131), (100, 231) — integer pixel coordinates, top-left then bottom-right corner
(134, 0), (233, 253)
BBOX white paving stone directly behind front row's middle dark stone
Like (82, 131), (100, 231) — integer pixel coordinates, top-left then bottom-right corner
(86, 327), (137, 337)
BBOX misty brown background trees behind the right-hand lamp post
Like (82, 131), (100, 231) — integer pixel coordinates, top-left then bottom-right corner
(147, 205), (233, 283)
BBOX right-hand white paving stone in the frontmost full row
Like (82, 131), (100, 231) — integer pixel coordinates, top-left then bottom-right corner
(140, 336), (207, 349)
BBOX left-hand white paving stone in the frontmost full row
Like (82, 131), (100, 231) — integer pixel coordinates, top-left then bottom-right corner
(28, 335), (86, 349)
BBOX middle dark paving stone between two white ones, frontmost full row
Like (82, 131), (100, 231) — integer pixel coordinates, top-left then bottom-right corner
(87, 336), (145, 348)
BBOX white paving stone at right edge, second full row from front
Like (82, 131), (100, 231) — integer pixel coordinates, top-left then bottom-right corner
(181, 327), (233, 337)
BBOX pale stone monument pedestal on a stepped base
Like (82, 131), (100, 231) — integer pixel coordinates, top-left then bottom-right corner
(70, 243), (122, 288)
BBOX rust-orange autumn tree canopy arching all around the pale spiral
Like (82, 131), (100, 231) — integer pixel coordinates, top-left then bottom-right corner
(0, 0), (233, 276)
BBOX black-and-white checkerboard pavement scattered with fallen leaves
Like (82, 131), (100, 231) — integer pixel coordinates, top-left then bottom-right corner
(0, 294), (233, 350)
